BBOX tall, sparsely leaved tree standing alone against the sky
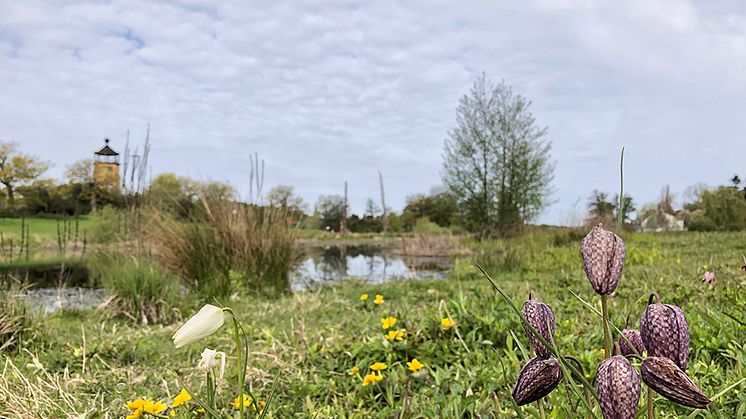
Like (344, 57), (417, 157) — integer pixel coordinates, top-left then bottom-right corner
(443, 74), (554, 235)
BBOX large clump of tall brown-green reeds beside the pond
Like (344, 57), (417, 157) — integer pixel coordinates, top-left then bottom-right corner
(154, 200), (295, 296)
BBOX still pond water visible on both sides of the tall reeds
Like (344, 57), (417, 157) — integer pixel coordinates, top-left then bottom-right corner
(5, 244), (452, 313)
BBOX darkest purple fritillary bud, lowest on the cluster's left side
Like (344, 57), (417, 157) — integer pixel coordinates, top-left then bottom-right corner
(513, 356), (562, 406)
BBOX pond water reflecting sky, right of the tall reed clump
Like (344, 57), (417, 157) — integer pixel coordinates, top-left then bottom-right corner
(290, 245), (449, 291)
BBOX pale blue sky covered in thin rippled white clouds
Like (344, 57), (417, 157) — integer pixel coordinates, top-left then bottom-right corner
(0, 0), (746, 224)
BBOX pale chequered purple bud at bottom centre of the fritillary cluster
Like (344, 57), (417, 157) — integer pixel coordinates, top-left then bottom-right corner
(596, 355), (640, 419)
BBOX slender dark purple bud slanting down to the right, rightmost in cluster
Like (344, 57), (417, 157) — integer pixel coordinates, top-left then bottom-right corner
(640, 356), (710, 409)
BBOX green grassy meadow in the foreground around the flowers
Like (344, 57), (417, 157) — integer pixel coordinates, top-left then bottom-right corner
(0, 231), (746, 418)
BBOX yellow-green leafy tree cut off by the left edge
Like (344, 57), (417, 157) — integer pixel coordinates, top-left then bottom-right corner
(0, 143), (49, 205)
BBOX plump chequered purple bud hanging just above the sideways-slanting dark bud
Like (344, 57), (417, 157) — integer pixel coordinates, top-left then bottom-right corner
(640, 294), (689, 370)
